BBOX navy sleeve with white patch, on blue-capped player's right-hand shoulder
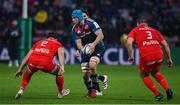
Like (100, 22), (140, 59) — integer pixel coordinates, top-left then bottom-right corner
(87, 18), (101, 32)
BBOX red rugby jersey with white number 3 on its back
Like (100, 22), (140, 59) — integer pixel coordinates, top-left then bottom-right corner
(128, 23), (164, 58)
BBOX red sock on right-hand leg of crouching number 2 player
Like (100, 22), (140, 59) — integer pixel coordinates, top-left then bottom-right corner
(56, 75), (64, 93)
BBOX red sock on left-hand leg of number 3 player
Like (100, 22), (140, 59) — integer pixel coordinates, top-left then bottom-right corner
(143, 77), (159, 96)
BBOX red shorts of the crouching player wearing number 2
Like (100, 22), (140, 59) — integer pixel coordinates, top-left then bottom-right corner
(28, 61), (57, 73)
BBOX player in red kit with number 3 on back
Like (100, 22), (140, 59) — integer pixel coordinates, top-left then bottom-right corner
(127, 19), (173, 101)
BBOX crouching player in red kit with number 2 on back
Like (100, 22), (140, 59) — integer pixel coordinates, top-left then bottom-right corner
(15, 33), (70, 99)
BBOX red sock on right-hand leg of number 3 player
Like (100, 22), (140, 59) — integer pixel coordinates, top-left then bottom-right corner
(155, 72), (168, 91)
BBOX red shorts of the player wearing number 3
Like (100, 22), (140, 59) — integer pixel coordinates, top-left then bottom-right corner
(139, 54), (163, 72)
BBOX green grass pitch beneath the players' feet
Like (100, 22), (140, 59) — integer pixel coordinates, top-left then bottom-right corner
(0, 64), (180, 104)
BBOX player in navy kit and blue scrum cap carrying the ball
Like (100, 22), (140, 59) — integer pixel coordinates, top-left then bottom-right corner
(72, 9), (107, 97)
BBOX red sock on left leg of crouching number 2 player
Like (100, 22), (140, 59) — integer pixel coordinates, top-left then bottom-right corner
(21, 71), (32, 89)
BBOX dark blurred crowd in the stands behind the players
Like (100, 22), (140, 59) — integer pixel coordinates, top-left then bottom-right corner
(0, 0), (180, 47)
